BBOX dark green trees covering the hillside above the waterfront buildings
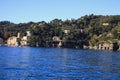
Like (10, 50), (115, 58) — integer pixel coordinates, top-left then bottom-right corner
(0, 14), (120, 48)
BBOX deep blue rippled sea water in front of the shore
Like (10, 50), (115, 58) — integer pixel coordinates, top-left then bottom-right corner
(0, 47), (120, 80)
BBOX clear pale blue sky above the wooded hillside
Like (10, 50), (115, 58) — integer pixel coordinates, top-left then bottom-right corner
(0, 0), (120, 23)
